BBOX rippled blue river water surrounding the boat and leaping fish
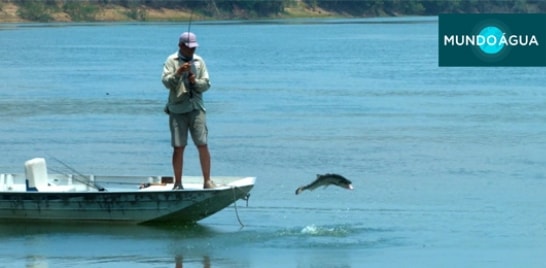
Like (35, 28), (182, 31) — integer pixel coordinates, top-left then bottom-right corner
(0, 17), (546, 267)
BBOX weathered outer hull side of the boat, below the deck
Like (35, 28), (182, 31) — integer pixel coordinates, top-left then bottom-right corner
(0, 178), (254, 224)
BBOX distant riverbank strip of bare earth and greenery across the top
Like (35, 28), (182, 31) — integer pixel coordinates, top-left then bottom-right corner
(0, 0), (546, 23)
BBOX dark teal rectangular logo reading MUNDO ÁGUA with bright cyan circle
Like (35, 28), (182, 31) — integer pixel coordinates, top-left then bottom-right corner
(438, 14), (546, 66)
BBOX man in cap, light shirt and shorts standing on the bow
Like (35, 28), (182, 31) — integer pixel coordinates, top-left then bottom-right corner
(161, 32), (215, 190)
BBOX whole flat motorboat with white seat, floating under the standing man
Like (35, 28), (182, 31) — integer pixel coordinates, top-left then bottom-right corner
(0, 158), (256, 224)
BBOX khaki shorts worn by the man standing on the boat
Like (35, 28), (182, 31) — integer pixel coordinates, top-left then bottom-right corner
(169, 110), (208, 147)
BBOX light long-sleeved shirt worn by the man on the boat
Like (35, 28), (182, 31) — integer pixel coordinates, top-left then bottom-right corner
(161, 52), (210, 114)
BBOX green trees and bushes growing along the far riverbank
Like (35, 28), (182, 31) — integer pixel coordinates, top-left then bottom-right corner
(9, 0), (546, 21)
